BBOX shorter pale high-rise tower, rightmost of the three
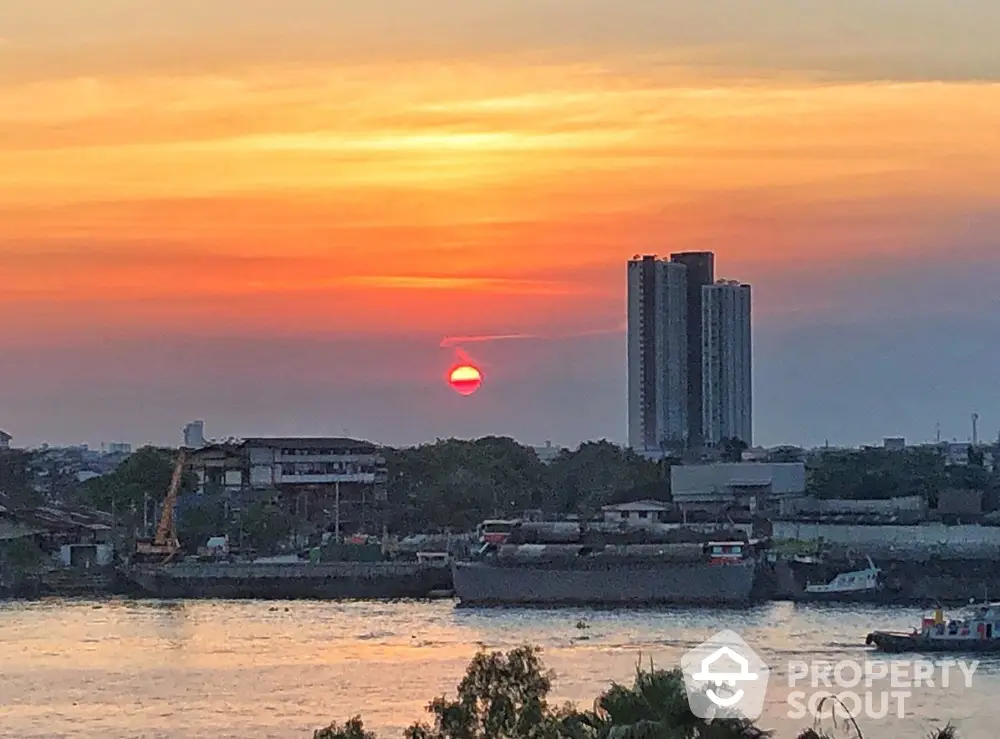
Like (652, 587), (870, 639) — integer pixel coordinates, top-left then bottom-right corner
(702, 281), (753, 446)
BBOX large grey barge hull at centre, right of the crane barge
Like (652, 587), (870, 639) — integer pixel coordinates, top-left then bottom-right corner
(452, 561), (757, 606)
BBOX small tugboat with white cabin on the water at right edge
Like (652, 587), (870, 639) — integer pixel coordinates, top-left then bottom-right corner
(865, 603), (1000, 653)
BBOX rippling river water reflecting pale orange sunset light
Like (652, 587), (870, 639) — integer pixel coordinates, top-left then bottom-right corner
(0, 601), (1000, 739)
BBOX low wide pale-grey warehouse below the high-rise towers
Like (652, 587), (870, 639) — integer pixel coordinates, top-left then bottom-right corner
(670, 462), (806, 511)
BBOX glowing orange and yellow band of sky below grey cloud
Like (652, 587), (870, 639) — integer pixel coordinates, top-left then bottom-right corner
(0, 47), (1000, 342)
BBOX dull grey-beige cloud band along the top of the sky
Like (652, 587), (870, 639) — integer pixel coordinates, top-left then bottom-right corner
(0, 0), (1000, 79)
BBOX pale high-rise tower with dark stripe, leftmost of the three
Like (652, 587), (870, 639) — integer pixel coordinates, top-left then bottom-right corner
(628, 256), (689, 450)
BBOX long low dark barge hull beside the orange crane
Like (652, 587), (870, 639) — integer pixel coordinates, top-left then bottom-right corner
(129, 562), (451, 600)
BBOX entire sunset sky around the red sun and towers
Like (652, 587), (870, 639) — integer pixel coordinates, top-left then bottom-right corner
(0, 0), (1000, 446)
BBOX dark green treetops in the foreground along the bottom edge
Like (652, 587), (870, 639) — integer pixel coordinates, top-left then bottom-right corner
(313, 646), (957, 739)
